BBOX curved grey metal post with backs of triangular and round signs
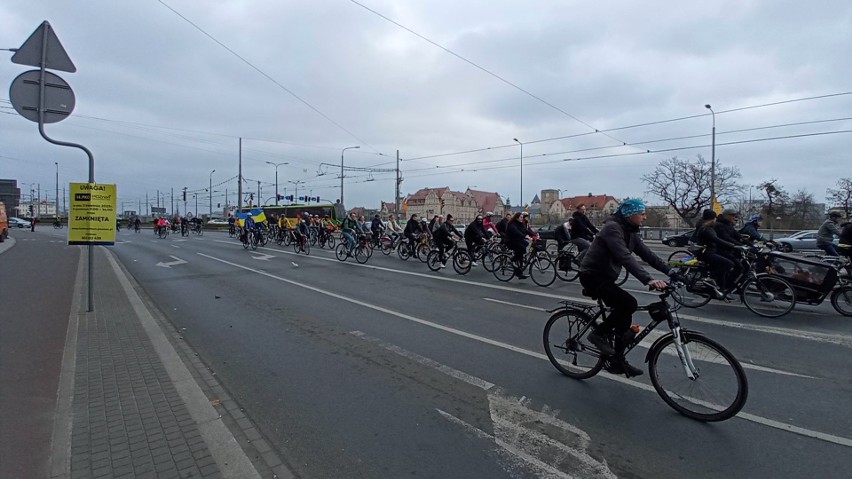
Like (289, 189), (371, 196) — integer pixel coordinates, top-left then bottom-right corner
(9, 20), (95, 311)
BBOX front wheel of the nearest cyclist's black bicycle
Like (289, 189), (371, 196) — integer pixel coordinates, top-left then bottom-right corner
(648, 331), (748, 421)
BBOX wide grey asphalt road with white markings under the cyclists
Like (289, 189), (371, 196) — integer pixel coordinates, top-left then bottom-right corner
(56, 230), (852, 478)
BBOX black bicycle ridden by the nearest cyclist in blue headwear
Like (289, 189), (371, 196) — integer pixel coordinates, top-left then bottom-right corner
(544, 282), (748, 422)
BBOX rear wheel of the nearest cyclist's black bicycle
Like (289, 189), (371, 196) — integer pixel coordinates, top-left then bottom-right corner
(544, 309), (604, 379)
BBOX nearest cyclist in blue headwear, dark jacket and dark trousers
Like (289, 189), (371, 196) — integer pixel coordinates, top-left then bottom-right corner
(575, 198), (674, 376)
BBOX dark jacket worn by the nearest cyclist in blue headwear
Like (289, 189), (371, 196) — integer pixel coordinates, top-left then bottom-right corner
(575, 213), (670, 284)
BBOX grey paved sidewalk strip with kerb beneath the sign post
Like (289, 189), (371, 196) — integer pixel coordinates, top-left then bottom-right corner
(51, 248), (264, 478)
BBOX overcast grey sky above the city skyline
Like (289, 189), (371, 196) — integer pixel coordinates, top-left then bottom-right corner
(0, 0), (852, 213)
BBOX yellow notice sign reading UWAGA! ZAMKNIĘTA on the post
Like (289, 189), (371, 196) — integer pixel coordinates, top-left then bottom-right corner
(68, 183), (116, 245)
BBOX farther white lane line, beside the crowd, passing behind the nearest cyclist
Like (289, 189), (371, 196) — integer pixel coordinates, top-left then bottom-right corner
(210, 240), (852, 348)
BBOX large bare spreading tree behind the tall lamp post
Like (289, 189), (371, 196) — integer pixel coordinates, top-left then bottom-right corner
(642, 155), (740, 226)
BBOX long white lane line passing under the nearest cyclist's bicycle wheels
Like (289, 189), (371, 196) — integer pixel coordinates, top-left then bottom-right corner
(196, 253), (852, 447)
